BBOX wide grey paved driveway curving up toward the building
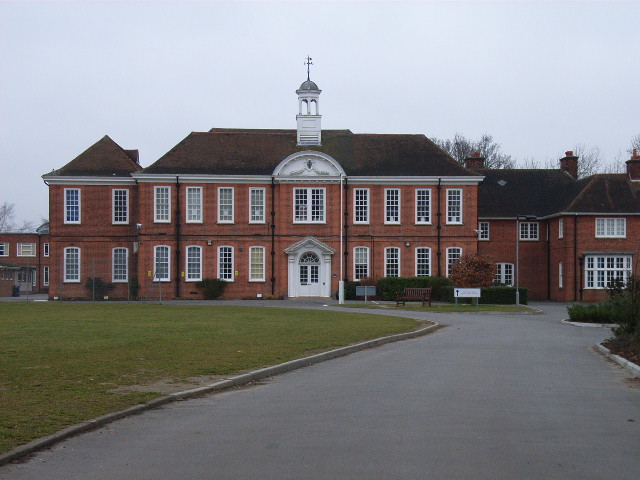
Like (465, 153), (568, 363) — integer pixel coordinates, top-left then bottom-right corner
(0, 304), (640, 480)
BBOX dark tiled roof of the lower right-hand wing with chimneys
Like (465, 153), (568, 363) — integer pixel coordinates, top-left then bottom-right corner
(474, 169), (640, 218)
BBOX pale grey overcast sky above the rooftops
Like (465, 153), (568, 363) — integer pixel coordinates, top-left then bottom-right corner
(0, 0), (640, 222)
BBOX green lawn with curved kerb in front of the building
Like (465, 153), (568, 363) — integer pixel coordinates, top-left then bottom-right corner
(0, 303), (417, 452)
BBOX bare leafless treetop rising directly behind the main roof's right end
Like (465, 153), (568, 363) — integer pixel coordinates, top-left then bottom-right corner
(432, 133), (516, 168)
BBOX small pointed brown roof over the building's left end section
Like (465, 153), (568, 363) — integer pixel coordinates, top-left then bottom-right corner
(44, 135), (142, 177)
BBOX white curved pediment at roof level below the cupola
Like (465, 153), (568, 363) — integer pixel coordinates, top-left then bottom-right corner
(273, 150), (345, 181)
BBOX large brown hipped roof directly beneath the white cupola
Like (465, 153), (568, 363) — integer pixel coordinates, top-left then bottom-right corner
(143, 128), (473, 176)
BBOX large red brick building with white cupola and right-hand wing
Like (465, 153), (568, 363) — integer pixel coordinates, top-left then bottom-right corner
(20, 80), (640, 301)
